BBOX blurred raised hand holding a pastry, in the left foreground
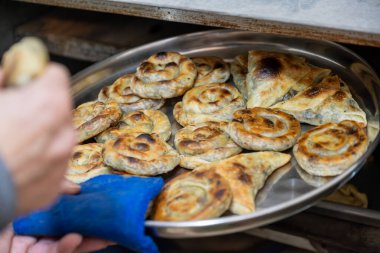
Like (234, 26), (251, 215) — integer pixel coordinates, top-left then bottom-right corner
(0, 64), (75, 215)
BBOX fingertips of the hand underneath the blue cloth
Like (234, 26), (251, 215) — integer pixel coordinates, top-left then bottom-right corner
(0, 226), (112, 253)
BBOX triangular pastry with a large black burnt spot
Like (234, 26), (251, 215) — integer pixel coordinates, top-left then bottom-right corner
(246, 50), (330, 108)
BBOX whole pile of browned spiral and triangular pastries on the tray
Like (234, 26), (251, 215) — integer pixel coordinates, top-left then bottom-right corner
(67, 50), (368, 221)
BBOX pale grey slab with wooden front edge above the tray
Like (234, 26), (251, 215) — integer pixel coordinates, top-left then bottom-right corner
(14, 0), (380, 46)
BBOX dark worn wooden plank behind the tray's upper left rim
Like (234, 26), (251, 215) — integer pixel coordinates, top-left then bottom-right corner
(16, 10), (206, 61)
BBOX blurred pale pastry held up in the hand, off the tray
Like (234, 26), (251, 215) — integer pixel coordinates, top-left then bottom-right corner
(2, 37), (49, 86)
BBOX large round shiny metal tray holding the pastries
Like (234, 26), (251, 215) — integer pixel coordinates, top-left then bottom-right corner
(73, 30), (380, 238)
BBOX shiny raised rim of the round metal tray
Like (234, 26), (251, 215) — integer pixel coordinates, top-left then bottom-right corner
(72, 29), (380, 238)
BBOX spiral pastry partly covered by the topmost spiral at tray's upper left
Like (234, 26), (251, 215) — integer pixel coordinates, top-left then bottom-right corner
(98, 74), (165, 113)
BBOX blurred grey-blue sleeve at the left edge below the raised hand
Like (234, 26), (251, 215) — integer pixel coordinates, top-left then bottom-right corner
(0, 159), (16, 231)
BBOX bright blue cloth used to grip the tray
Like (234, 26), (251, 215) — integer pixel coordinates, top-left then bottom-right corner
(13, 175), (163, 253)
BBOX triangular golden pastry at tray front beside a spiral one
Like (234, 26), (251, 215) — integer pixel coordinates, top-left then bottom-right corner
(200, 151), (291, 214)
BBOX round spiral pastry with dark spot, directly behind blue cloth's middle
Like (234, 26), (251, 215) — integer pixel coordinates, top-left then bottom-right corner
(103, 133), (179, 176)
